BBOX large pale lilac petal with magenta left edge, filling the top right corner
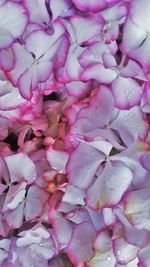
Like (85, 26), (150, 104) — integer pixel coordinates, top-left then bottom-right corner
(122, 0), (150, 68)
